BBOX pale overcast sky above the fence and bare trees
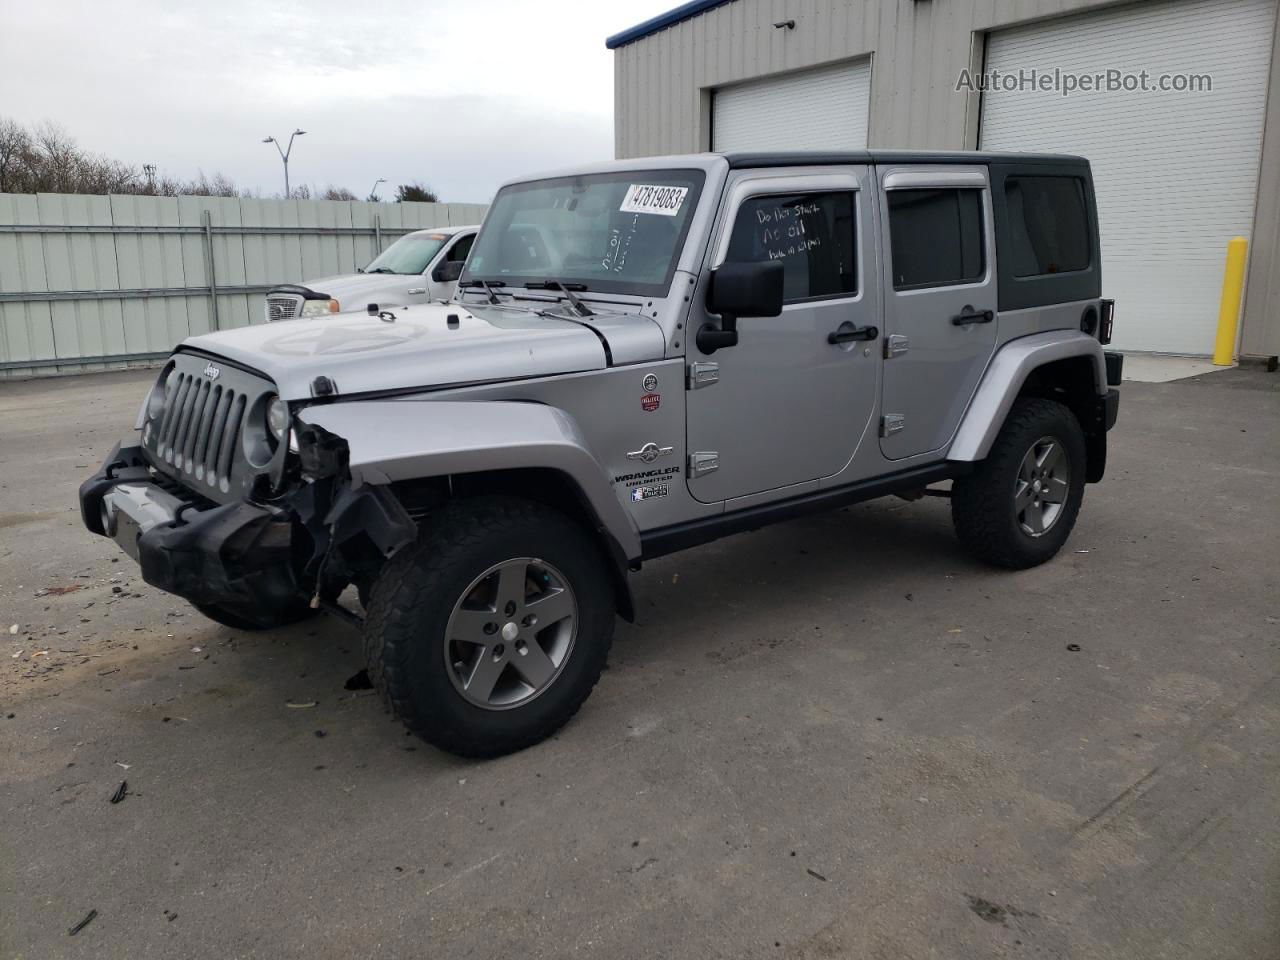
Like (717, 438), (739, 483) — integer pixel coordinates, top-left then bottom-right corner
(0, 0), (678, 201)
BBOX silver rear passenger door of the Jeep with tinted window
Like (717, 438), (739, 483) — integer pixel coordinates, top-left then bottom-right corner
(878, 165), (997, 460)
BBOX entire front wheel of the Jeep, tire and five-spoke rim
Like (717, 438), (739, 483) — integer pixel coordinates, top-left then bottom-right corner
(365, 498), (614, 756)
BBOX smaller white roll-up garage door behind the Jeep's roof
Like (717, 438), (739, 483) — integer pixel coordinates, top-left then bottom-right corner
(712, 59), (872, 152)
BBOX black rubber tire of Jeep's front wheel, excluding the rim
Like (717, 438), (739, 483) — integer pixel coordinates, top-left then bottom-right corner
(364, 497), (616, 758)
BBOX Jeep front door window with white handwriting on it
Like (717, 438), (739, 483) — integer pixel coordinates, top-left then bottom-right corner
(726, 192), (858, 303)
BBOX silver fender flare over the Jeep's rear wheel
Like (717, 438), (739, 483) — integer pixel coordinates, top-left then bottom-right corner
(947, 330), (1107, 461)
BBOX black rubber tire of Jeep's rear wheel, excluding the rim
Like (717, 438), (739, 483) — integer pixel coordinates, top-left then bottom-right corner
(951, 397), (1085, 570)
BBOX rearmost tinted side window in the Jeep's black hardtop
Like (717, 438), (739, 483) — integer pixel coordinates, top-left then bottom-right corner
(1005, 177), (1089, 276)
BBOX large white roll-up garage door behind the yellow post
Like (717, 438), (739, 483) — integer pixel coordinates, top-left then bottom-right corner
(980, 0), (1276, 355)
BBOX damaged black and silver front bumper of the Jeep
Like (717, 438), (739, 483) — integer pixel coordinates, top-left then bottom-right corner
(79, 444), (302, 609)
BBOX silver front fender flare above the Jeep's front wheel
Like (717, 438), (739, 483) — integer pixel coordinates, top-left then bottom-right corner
(300, 401), (640, 568)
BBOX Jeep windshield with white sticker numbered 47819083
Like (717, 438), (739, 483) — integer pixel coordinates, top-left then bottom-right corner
(463, 170), (704, 297)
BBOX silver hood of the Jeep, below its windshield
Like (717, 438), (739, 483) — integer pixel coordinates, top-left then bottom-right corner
(182, 303), (666, 401)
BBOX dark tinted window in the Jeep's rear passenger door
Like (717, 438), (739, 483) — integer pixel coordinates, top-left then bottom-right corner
(888, 188), (986, 291)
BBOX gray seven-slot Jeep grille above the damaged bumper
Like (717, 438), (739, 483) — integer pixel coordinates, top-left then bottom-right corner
(142, 353), (284, 503)
